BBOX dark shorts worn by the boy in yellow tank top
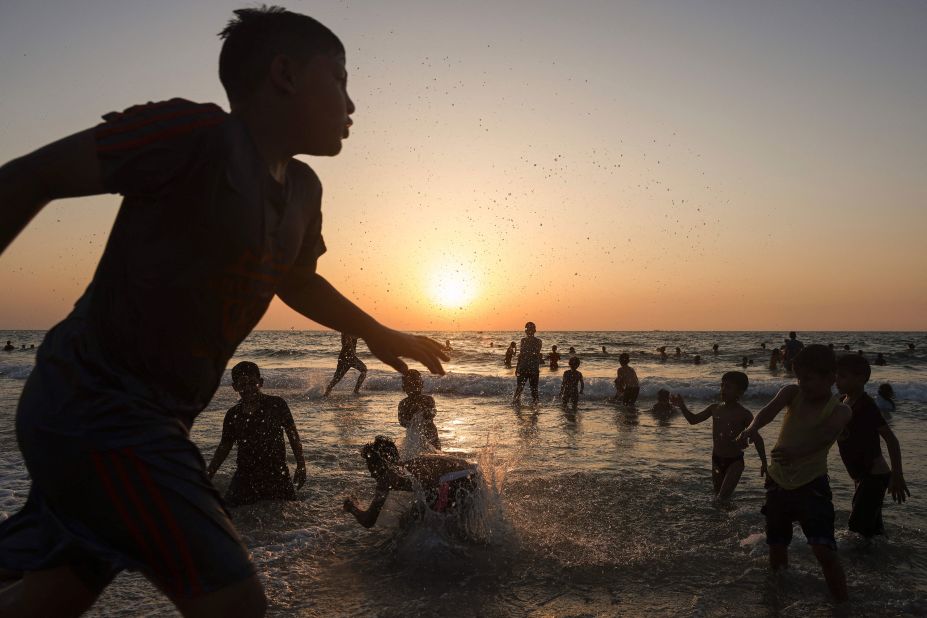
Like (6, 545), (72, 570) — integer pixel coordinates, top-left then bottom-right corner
(762, 474), (837, 549)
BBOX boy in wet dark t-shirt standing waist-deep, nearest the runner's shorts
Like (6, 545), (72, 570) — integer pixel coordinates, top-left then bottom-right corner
(206, 361), (306, 506)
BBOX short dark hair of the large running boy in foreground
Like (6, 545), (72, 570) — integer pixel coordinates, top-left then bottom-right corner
(219, 5), (344, 104)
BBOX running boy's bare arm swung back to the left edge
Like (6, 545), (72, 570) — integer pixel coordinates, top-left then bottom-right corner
(0, 129), (106, 253)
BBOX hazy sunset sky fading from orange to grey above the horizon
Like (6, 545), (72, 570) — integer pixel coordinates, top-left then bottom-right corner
(0, 1), (927, 330)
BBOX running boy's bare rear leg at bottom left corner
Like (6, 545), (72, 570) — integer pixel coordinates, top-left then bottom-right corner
(0, 566), (97, 618)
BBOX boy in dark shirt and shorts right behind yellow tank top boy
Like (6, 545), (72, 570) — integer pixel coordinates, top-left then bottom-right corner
(837, 354), (911, 538)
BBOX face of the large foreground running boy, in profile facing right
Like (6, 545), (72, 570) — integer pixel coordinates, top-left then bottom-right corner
(288, 54), (355, 156)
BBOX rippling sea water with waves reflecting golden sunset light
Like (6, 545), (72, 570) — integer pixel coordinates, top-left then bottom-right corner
(0, 331), (927, 616)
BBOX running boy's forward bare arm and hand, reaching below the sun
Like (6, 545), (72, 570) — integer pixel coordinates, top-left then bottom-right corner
(277, 273), (450, 375)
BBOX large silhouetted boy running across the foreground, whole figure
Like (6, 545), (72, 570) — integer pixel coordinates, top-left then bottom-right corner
(0, 7), (447, 616)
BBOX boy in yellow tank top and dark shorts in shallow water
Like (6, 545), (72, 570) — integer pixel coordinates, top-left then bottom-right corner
(741, 345), (852, 603)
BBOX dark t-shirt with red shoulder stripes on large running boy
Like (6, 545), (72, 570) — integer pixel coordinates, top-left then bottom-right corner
(37, 99), (325, 426)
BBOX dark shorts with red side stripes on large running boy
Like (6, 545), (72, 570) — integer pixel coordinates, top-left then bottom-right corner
(0, 356), (255, 597)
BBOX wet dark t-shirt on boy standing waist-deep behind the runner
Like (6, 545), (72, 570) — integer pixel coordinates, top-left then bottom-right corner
(222, 393), (293, 478)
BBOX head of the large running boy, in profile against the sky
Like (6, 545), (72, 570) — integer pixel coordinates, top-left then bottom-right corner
(219, 6), (354, 156)
